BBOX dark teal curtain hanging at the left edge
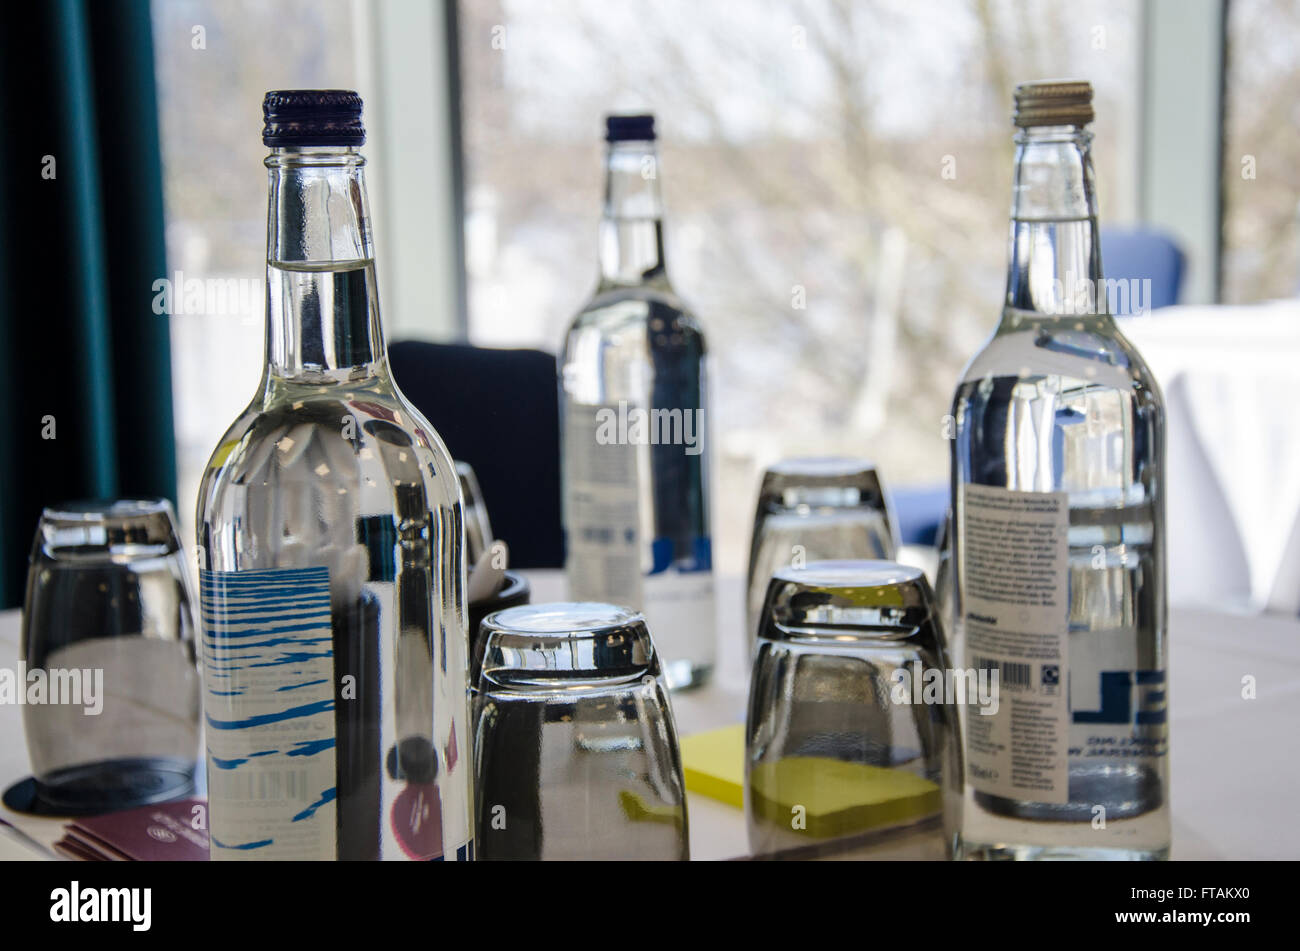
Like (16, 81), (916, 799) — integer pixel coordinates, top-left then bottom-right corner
(0, 0), (176, 607)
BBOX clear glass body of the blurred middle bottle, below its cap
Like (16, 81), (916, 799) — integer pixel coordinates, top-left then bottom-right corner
(560, 135), (716, 687)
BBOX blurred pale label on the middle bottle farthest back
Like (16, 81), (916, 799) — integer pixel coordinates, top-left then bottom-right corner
(564, 401), (645, 611)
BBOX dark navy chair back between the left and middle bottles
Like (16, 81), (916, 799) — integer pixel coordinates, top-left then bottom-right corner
(389, 340), (564, 568)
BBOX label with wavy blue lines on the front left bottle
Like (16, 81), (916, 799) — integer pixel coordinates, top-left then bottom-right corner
(199, 568), (337, 860)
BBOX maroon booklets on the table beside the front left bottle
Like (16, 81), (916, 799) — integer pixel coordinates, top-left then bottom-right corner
(55, 799), (208, 861)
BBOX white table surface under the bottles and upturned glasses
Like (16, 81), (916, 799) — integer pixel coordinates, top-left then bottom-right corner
(0, 572), (1300, 859)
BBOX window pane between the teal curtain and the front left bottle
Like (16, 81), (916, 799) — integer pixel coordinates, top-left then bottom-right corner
(153, 0), (356, 544)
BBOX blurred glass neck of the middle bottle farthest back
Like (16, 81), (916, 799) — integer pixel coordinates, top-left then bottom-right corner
(601, 142), (668, 290)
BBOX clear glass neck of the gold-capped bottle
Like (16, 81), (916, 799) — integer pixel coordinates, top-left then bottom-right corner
(1006, 126), (1108, 320)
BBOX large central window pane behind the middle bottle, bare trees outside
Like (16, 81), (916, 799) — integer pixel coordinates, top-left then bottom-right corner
(459, 0), (1140, 574)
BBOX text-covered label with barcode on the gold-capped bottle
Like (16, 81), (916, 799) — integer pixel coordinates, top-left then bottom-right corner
(958, 485), (1070, 803)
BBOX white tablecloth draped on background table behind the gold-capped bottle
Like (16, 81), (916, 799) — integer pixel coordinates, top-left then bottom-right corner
(1121, 300), (1300, 616)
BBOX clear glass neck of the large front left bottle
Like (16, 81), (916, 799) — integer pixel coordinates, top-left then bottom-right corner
(265, 147), (387, 385)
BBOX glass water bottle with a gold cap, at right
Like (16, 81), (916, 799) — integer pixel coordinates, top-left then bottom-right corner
(952, 82), (1170, 859)
